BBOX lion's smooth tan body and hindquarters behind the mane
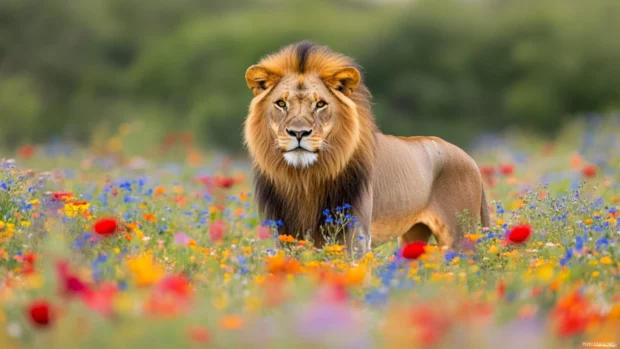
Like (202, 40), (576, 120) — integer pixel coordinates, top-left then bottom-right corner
(370, 134), (488, 246)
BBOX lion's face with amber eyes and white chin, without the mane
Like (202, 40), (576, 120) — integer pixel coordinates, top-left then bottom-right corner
(265, 75), (338, 168)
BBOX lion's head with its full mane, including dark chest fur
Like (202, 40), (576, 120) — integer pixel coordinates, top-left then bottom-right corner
(244, 42), (376, 244)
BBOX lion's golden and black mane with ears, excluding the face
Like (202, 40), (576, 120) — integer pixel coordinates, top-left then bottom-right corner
(244, 41), (378, 245)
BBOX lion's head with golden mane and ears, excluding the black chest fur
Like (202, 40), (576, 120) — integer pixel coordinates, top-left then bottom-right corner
(245, 42), (374, 182)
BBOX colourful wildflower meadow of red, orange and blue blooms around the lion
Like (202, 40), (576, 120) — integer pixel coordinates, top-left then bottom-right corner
(0, 118), (620, 349)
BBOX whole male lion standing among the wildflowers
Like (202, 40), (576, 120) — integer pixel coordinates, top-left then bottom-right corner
(243, 41), (489, 253)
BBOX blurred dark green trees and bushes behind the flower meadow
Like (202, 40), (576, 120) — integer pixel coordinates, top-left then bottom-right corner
(0, 0), (620, 150)
